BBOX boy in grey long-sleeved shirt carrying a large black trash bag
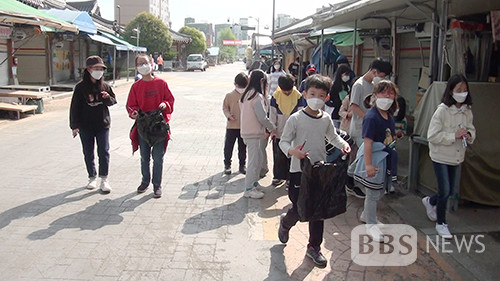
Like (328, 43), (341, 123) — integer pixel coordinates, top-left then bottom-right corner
(278, 74), (351, 267)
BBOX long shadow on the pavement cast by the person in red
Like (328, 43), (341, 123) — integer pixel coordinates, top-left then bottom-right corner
(28, 192), (153, 240)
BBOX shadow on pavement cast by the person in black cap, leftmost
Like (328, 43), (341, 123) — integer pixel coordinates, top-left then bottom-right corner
(0, 187), (99, 229)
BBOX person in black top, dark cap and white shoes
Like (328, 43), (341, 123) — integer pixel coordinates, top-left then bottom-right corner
(69, 56), (116, 193)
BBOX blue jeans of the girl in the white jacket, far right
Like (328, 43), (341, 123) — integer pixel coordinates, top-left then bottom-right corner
(430, 161), (460, 224)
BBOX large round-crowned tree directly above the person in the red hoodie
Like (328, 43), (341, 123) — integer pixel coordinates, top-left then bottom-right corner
(123, 12), (172, 53)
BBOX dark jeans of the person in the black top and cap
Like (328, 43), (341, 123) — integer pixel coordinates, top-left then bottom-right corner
(79, 128), (109, 178)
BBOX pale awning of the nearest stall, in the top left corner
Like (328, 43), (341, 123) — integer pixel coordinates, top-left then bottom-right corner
(0, 0), (78, 33)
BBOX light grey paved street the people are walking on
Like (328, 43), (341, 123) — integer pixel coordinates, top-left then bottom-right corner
(0, 62), (495, 281)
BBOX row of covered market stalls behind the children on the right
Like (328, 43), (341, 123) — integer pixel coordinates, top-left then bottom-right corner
(273, 0), (500, 206)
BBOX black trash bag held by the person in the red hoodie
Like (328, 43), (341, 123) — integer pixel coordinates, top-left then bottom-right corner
(135, 109), (170, 146)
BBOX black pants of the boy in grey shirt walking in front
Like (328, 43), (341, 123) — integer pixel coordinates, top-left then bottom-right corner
(283, 172), (324, 247)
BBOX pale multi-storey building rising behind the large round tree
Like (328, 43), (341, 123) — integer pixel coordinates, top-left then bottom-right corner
(115, 0), (171, 27)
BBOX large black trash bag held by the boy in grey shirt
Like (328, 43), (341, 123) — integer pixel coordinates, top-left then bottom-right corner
(297, 157), (349, 222)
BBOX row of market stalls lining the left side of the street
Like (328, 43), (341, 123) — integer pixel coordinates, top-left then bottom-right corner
(0, 0), (147, 88)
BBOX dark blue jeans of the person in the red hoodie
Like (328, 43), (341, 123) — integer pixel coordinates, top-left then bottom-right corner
(139, 136), (165, 186)
